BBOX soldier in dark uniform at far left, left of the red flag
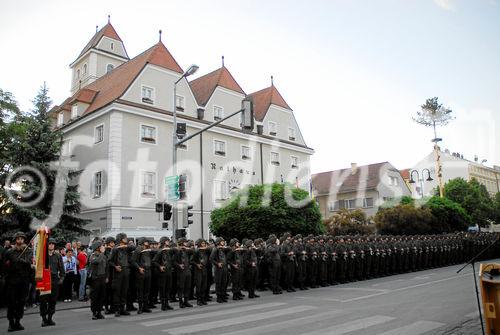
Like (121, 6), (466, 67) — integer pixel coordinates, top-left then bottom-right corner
(4, 232), (34, 332)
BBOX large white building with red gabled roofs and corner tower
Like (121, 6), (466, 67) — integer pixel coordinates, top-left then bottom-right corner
(52, 23), (314, 242)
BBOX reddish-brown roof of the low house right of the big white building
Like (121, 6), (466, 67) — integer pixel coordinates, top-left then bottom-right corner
(311, 162), (397, 195)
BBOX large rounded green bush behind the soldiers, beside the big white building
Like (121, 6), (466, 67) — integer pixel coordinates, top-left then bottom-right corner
(210, 183), (323, 239)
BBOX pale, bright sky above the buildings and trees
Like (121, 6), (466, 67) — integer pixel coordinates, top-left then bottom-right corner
(0, 0), (500, 173)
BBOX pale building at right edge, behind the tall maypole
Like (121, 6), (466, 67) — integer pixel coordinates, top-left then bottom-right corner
(408, 150), (500, 198)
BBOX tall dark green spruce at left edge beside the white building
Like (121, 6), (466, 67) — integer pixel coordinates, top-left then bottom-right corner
(0, 85), (88, 240)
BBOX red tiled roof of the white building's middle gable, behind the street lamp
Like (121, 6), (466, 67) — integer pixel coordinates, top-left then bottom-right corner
(189, 66), (245, 106)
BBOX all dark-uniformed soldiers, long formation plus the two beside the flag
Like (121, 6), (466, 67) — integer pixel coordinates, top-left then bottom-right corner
(2, 233), (500, 331)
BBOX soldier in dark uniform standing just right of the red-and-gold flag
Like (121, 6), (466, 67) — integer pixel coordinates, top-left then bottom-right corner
(40, 238), (66, 327)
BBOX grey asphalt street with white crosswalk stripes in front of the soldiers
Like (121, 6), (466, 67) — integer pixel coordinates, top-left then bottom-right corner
(0, 260), (492, 335)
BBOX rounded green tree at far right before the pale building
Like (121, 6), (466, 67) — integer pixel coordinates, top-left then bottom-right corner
(444, 178), (495, 227)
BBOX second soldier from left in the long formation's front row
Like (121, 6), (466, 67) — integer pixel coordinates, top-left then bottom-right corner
(109, 233), (135, 317)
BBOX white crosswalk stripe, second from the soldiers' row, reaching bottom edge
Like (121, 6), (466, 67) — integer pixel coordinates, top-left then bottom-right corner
(162, 306), (316, 335)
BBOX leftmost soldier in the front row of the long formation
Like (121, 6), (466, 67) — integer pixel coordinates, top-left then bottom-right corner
(89, 241), (108, 320)
